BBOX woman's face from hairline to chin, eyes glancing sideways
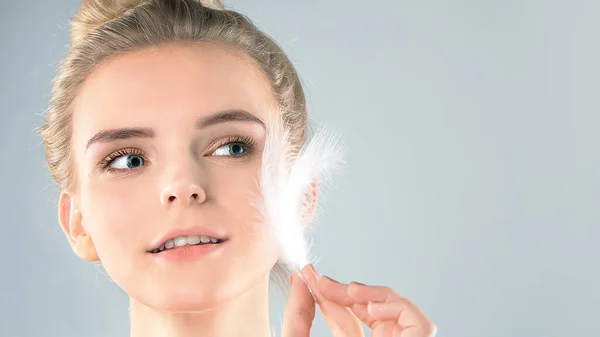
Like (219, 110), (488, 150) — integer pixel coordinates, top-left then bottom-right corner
(61, 45), (277, 311)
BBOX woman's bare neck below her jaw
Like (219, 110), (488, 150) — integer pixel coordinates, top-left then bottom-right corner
(130, 282), (271, 337)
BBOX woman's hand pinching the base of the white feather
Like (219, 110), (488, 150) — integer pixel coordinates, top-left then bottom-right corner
(283, 265), (436, 337)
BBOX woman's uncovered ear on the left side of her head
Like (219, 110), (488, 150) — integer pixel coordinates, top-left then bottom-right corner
(58, 191), (99, 262)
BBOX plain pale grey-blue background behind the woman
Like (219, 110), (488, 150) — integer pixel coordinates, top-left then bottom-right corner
(0, 0), (600, 337)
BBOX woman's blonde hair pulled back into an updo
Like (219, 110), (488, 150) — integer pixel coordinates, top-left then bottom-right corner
(39, 0), (307, 290)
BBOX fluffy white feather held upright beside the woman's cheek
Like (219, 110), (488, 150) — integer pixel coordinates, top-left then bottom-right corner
(254, 110), (347, 271)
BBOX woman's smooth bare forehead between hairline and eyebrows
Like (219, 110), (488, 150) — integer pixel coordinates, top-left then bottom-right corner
(73, 44), (276, 136)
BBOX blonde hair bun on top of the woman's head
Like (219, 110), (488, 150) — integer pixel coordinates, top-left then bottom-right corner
(70, 0), (225, 45)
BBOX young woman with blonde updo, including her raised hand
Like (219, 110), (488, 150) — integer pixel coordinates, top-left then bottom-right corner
(40, 0), (435, 337)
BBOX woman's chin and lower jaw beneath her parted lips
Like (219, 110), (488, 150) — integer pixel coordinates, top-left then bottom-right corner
(115, 246), (277, 313)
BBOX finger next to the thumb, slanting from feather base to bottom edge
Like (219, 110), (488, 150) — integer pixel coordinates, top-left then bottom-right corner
(302, 265), (364, 337)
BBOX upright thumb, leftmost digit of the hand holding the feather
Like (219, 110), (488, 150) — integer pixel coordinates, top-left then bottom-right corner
(282, 274), (315, 337)
